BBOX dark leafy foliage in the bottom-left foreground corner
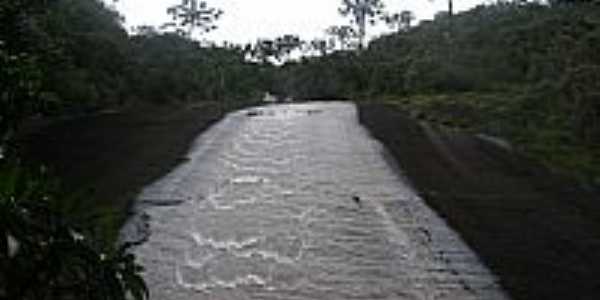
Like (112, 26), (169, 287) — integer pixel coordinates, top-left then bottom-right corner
(0, 163), (148, 300)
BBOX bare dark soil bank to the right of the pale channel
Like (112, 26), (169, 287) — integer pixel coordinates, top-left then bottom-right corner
(359, 103), (600, 300)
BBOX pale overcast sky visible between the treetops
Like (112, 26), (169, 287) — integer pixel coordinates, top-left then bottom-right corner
(111, 0), (485, 44)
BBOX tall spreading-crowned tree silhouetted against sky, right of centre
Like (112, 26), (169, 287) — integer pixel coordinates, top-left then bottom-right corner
(339, 0), (385, 50)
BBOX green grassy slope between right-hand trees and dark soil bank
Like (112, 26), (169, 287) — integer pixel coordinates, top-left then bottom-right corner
(378, 92), (600, 185)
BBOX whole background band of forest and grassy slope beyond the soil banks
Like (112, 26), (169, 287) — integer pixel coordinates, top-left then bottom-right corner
(5, 0), (600, 188)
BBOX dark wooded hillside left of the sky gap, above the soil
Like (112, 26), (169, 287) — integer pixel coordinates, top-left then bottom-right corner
(0, 0), (271, 122)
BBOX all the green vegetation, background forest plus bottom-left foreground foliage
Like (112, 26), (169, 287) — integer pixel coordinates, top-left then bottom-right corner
(0, 0), (600, 299)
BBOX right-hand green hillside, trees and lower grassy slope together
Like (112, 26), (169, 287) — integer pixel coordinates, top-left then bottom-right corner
(280, 1), (600, 180)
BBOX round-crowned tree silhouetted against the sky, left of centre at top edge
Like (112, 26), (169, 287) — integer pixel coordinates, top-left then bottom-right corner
(164, 0), (223, 37)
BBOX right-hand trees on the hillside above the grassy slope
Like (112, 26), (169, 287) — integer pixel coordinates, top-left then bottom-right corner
(284, 2), (600, 95)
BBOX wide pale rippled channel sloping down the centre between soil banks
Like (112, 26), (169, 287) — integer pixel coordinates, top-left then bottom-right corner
(123, 102), (507, 300)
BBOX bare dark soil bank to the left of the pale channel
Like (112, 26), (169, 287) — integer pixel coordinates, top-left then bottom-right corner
(18, 105), (222, 238)
